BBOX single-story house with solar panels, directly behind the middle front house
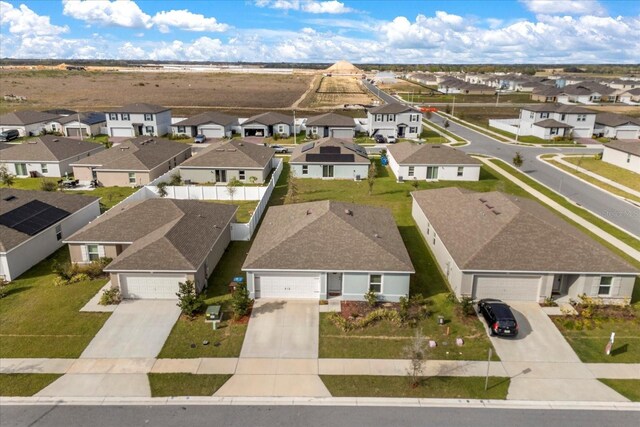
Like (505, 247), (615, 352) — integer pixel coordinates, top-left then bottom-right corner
(289, 138), (371, 179)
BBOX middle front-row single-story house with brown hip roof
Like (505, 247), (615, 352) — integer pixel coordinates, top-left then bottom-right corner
(242, 200), (415, 301)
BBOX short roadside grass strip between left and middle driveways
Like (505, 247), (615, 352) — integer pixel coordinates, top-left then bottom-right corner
(147, 374), (231, 397)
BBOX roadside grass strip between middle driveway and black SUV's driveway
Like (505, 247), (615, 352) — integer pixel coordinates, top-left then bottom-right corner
(320, 375), (510, 399)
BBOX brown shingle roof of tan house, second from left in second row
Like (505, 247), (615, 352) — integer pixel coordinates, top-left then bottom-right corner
(72, 136), (191, 171)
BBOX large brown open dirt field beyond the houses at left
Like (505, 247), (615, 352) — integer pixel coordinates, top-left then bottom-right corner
(0, 70), (313, 112)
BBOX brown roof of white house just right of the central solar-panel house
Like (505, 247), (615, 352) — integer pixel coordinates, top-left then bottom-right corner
(387, 142), (480, 165)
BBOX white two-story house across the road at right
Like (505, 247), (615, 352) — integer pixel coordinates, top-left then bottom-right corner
(518, 104), (596, 139)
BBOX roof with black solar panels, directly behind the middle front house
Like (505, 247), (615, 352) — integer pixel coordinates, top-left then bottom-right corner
(289, 137), (371, 164)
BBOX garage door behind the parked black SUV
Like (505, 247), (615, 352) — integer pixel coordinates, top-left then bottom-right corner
(473, 276), (540, 301)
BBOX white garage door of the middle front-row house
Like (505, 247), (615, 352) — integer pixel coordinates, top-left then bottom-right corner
(254, 274), (320, 299)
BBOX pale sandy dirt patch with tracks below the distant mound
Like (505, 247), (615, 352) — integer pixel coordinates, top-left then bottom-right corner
(300, 76), (375, 108)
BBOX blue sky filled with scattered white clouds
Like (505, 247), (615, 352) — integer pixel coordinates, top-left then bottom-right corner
(0, 0), (640, 63)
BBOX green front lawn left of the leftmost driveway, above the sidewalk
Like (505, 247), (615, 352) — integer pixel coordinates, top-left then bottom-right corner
(0, 246), (109, 358)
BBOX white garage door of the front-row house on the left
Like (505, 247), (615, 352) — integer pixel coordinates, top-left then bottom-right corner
(120, 274), (186, 299)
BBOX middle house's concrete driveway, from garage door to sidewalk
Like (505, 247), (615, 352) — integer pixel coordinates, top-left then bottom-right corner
(240, 299), (320, 359)
